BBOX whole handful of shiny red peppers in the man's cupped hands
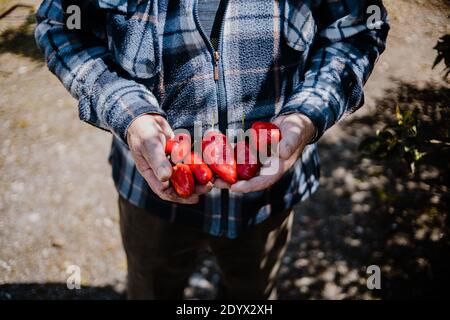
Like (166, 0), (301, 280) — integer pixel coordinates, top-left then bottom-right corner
(165, 121), (281, 197)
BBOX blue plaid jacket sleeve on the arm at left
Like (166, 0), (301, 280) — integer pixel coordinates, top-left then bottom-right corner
(35, 0), (165, 141)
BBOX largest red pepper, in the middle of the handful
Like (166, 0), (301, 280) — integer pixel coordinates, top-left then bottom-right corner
(202, 131), (237, 184)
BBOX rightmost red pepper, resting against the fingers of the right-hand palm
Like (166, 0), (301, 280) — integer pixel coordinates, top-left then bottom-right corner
(250, 121), (281, 156)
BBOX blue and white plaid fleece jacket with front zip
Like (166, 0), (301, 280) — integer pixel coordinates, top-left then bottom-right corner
(36, 0), (389, 238)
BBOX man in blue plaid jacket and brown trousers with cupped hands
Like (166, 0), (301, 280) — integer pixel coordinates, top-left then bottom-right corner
(36, 0), (389, 299)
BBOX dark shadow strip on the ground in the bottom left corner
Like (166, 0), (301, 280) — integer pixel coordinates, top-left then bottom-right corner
(0, 283), (125, 300)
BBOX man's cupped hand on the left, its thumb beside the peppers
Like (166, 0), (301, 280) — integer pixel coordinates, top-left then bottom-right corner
(127, 114), (212, 204)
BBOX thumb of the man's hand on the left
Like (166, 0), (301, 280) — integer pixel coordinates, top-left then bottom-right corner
(143, 138), (172, 182)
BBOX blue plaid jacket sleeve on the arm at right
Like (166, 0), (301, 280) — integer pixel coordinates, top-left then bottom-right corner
(280, 0), (389, 143)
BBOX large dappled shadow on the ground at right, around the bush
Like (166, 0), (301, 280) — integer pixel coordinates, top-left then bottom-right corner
(280, 83), (450, 299)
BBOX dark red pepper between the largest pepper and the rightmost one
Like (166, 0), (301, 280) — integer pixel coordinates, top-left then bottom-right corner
(234, 140), (261, 180)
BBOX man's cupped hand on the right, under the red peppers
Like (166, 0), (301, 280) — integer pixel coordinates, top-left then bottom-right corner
(229, 113), (316, 193)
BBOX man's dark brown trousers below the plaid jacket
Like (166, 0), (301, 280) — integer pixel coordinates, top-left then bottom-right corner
(119, 197), (293, 299)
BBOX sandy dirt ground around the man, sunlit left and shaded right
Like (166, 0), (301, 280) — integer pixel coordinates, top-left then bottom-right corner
(0, 0), (450, 299)
